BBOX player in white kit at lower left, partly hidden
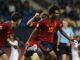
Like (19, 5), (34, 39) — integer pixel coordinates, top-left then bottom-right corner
(7, 35), (19, 60)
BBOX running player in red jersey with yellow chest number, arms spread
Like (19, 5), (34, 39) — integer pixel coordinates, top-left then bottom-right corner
(22, 6), (72, 60)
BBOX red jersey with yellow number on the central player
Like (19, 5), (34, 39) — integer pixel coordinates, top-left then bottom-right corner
(33, 19), (61, 43)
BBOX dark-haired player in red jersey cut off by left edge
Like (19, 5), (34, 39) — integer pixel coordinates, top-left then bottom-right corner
(0, 13), (21, 60)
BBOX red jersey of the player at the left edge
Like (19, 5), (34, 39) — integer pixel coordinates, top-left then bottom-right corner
(0, 21), (13, 48)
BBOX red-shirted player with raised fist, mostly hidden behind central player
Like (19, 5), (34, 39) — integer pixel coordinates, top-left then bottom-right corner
(22, 13), (49, 60)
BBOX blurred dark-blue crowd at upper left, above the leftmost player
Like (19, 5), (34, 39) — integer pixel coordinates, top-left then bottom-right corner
(0, 0), (36, 24)
